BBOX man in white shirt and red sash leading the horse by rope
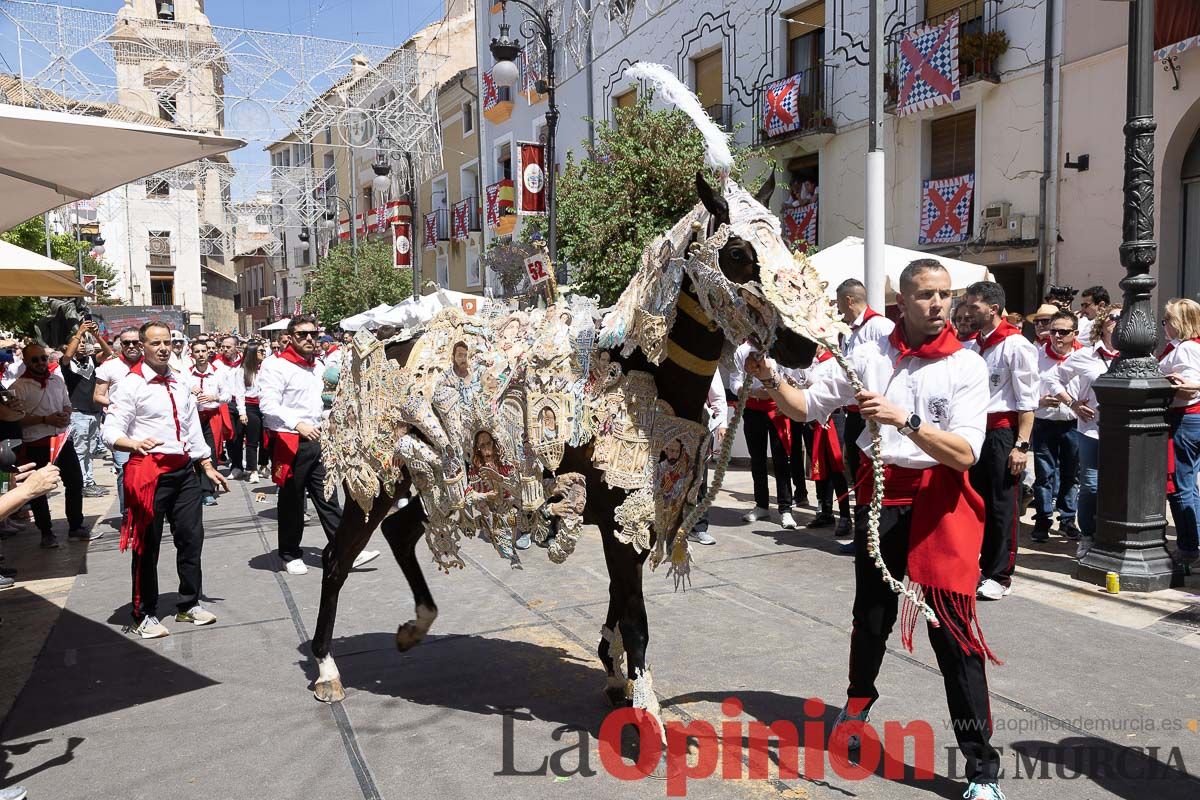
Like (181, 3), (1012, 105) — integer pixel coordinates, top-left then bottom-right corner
(746, 259), (1002, 800)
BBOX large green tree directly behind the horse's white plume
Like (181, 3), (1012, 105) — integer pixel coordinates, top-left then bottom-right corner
(557, 97), (762, 305)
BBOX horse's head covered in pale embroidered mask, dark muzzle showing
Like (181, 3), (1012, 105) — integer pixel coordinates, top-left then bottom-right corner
(696, 172), (840, 367)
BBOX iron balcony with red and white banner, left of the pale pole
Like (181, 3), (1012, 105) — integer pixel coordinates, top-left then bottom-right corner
(754, 64), (834, 145)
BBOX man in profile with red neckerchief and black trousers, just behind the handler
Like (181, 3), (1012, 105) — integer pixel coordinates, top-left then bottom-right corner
(962, 281), (1039, 600)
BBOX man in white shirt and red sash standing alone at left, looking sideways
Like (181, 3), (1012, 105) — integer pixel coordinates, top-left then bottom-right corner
(103, 321), (229, 639)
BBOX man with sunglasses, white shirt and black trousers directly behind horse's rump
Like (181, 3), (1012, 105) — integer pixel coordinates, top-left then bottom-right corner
(258, 315), (379, 575)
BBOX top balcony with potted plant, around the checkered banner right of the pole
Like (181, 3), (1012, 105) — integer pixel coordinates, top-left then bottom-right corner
(883, 0), (1009, 113)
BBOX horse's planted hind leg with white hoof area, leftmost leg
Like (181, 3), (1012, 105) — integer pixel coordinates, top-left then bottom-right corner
(311, 484), (391, 703)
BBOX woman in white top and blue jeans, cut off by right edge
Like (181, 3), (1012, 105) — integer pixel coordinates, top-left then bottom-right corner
(1158, 297), (1200, 564)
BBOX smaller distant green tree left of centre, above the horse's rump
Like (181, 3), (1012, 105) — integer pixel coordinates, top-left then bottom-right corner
(304, 239), (416, 327)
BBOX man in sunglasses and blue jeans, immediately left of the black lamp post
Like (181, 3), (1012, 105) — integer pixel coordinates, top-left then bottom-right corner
(1032, 311), (1082, 542)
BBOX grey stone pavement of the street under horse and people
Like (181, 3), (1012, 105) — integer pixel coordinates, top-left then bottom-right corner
(0, 462), (1200, 800)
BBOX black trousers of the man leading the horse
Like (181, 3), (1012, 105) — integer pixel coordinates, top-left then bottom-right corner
(846, 506), (1000, 783)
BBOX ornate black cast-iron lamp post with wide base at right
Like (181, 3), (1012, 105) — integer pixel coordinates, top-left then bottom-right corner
(1075, 0), (1176, 591)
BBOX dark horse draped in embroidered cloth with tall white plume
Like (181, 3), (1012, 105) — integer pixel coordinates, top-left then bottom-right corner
(304, 64), (900, 738)
